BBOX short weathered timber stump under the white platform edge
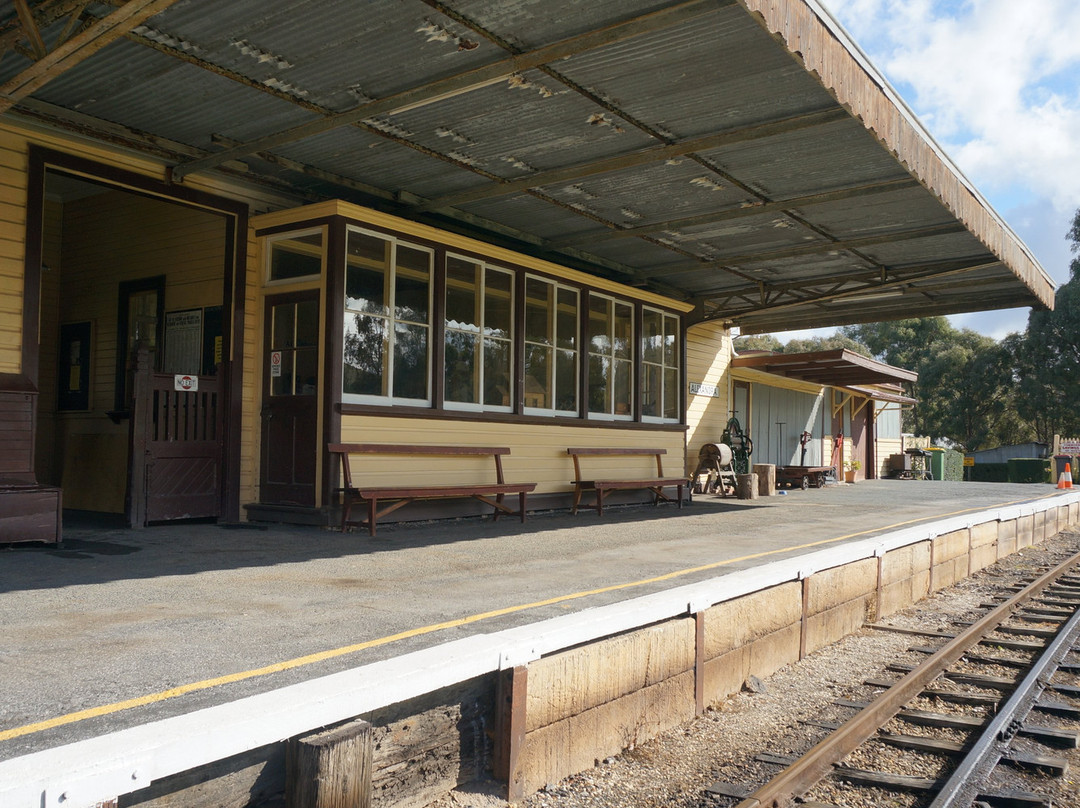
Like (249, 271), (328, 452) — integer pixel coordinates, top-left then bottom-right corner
(285, 719), (373, 808)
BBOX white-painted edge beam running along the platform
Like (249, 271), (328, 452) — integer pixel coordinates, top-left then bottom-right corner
(0, 490), (1080, 808)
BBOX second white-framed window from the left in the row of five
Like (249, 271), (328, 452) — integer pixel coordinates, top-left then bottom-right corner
(443, 255), (514, 412)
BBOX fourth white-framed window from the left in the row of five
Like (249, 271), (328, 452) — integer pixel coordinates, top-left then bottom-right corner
(589, 294), (634, 419)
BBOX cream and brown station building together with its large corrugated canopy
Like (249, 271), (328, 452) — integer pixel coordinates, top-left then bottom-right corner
(0, 0), (1053, 536)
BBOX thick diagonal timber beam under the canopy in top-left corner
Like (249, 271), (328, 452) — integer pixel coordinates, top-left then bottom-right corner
(0, 0), (177, 113)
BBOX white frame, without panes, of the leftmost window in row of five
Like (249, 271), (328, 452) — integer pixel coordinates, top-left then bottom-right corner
(340, 224), (434, 408)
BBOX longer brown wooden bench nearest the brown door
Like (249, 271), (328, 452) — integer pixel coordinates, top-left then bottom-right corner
(327, 443), (537, 536)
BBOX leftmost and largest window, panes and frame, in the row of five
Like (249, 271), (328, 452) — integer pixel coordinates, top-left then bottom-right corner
(341, 228), (433, 404)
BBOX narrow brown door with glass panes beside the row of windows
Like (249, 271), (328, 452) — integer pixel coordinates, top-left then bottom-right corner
(259, 292), (320, 508)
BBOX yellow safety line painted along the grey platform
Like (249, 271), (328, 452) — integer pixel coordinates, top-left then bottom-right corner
(0, 494), (1056, 743)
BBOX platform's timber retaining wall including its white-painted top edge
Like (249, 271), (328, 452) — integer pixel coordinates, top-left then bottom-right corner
(0, 493), (1080, 808)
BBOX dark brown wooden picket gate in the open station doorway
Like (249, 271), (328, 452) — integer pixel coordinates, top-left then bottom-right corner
(127, 351), (224, 527)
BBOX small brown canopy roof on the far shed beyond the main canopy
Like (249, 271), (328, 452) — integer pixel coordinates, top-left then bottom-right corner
(731, 348), (919, 387)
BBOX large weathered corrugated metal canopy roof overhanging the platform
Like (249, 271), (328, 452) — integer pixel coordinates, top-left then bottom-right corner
(0, 0), (1053, 333)
